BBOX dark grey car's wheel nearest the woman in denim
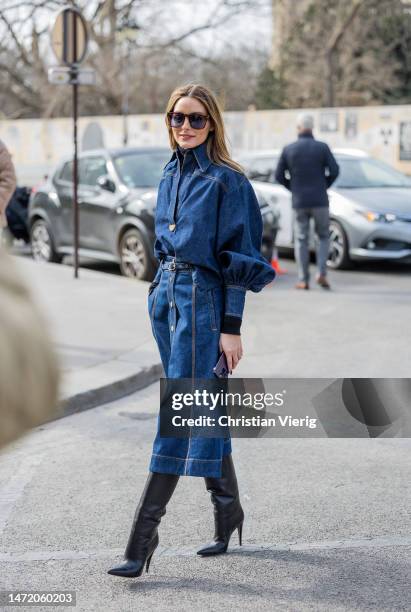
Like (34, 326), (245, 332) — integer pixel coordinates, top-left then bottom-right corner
(120, 228), (155, 280)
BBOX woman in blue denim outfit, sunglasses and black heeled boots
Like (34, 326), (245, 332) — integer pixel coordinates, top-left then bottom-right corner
(109, 84), (275, 577)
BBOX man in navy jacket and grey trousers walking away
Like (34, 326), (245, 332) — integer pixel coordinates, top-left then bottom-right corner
(275, 113), (339, 289)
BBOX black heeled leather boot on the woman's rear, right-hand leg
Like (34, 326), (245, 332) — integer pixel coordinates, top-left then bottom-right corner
(197, 454), (244, 556)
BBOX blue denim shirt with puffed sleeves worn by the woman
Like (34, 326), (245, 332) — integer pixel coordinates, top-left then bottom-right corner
(154, 142), (275, 330)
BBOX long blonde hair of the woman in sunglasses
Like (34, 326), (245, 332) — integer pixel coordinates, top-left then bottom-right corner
(166, 83), (244, 174)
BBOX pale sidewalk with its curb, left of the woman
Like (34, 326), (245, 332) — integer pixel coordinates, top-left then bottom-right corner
(15, 257), (163, 415)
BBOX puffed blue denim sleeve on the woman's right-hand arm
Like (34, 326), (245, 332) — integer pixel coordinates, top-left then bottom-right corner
(217, 176), (275, 334)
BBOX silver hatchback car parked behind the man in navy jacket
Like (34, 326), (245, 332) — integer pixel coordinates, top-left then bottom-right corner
(237, 149), (411, 269)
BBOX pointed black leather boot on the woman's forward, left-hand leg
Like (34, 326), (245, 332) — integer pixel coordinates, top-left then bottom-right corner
(108, 472), (179, 578)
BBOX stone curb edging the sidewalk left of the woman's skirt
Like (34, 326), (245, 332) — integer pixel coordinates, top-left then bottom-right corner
(50, 363), (164, 423)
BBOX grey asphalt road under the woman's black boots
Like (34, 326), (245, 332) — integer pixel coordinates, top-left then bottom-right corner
(0, 383), (411, 612)
